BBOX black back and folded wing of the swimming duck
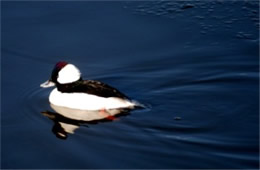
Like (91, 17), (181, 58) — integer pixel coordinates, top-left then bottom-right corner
(58, 80), (129, 99)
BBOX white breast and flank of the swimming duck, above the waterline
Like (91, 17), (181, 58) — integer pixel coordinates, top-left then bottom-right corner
(49, 88), (135, 110)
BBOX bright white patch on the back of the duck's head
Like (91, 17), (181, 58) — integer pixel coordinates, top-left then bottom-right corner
(57, 64), (80, 84)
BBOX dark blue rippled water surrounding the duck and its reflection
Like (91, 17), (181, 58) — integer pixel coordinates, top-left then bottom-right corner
(1, 1), (259, 169)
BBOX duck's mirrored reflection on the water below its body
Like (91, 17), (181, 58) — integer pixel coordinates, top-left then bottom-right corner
(41, 104), (130, 139)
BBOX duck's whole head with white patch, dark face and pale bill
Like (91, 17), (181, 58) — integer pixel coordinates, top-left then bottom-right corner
(40, 61), (81, 88)
